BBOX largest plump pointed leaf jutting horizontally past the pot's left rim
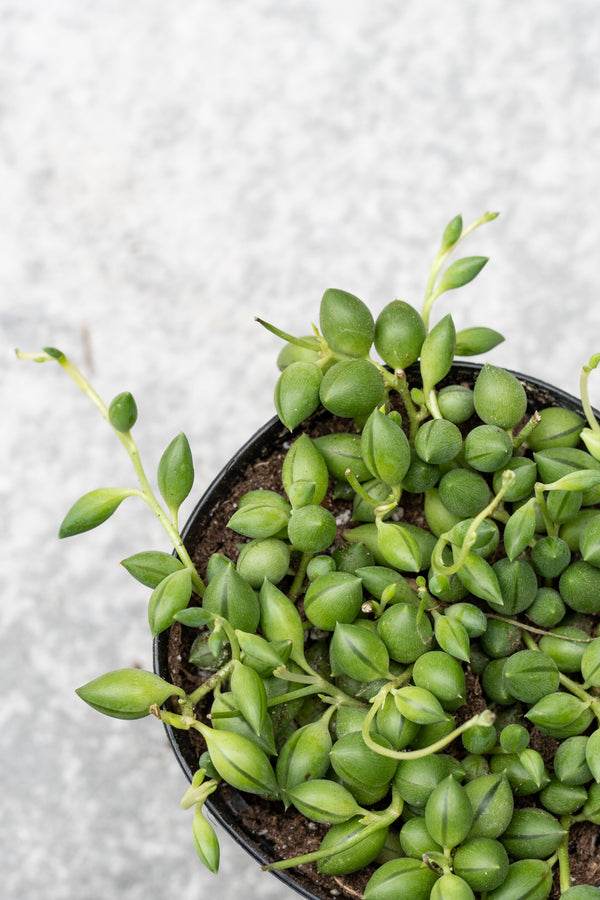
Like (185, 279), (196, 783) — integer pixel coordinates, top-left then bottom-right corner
(75, 669), (185, 719)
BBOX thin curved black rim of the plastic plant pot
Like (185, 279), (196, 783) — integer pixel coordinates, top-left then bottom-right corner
(153, 361), (584, 900)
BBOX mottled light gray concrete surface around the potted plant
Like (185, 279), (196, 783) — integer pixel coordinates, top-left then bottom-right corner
(0, 0), (600, 900)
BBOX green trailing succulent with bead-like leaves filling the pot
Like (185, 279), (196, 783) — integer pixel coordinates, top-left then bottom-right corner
(18, 213), (600, 900)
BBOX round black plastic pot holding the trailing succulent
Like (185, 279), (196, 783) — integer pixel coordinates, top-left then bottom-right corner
(154, 363), (583, 900)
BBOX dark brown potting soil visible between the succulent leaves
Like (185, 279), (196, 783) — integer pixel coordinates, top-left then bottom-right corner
(168, 376), (600, 900)
